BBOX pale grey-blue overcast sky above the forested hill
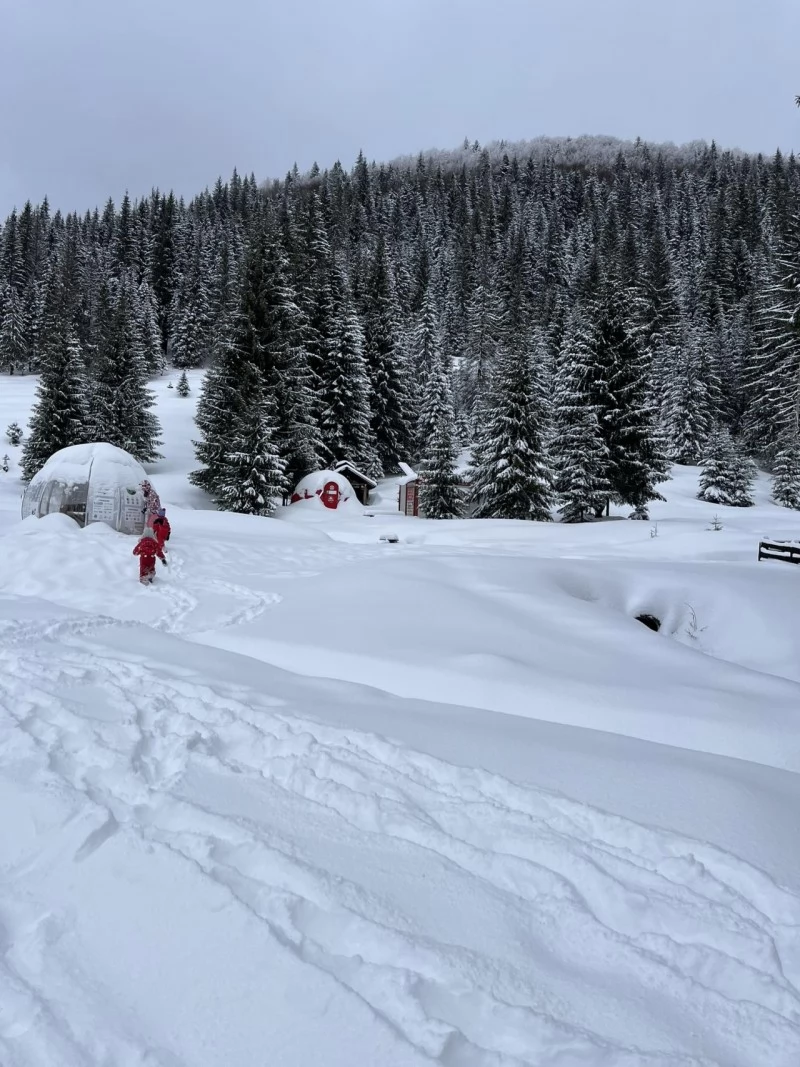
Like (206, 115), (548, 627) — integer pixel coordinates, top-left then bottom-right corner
(0, 0), (800, 216)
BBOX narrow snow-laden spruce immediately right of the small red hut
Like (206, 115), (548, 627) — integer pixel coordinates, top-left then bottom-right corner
(419, 356), (464, 519)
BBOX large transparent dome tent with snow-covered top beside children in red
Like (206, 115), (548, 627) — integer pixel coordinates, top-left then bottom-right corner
(22, 442), (147, 535)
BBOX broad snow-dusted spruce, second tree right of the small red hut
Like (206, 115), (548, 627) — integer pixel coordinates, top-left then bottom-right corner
(471, 349), (553, 522)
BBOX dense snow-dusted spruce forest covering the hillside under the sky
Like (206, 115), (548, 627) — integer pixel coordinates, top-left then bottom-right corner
(0, 139), (800, 521)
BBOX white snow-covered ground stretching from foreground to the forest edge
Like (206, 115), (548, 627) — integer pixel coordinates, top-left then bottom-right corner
(0, 375), (800, 1067)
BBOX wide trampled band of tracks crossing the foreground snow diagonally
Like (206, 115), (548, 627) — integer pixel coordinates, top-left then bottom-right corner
(0, 623), (800, 1067)
